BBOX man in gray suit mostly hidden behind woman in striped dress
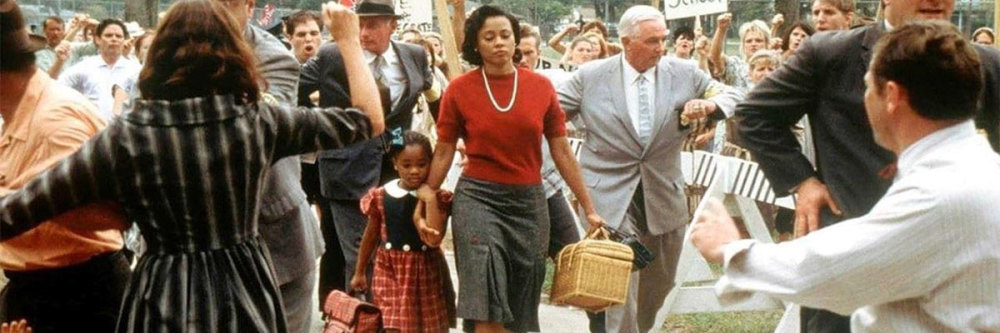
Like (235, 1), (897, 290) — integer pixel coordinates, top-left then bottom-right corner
(223, 0), (324, 332)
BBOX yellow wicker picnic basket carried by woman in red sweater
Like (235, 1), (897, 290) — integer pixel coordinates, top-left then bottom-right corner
(551, 229), (633, 312)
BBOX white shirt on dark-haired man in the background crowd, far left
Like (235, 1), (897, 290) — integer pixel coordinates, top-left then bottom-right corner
(59, 55), (142, 121)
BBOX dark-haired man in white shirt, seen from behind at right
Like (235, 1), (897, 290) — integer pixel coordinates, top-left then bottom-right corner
(692, 21), (1000, 332)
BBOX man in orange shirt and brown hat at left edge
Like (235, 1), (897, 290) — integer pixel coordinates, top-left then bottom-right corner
(0, 0), (131, 332)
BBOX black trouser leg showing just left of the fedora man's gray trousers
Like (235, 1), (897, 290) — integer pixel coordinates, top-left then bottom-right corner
(316, 198), (349, 310)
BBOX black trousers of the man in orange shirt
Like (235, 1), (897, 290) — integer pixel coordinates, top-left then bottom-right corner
(0, 251), (132, 333)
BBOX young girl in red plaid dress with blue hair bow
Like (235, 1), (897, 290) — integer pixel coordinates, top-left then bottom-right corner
(351, 130), (455, 333)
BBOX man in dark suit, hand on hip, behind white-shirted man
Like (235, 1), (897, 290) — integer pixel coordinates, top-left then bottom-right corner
(736, 0), (1000, 333)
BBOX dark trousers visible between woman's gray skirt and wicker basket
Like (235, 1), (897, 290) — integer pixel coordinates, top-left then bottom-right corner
(546, 190), (605, 333)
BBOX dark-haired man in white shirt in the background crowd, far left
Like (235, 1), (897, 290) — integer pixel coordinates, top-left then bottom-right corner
(59, 19), (142, 121)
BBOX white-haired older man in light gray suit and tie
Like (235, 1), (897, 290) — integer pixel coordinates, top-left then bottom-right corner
(558, 6), (742, 333)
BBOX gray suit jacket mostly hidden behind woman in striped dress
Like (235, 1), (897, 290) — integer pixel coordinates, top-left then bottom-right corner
(244, 25), (324, 285)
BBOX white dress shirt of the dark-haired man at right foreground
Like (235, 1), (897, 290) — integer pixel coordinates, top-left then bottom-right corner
(715, 121), (1000, 332)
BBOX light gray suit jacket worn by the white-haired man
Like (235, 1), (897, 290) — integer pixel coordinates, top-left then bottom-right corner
(558, 55), (743, 235)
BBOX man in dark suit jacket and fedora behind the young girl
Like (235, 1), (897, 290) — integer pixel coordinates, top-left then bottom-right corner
(299, 0), (440, 297)
